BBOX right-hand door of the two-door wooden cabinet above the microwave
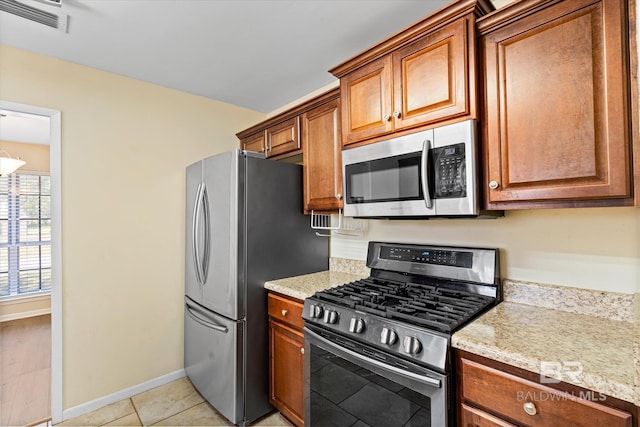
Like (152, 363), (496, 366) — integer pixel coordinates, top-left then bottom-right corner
(393, 18), (469, 130)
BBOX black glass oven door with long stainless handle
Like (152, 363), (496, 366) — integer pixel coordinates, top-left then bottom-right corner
(304, 325), (444, 427)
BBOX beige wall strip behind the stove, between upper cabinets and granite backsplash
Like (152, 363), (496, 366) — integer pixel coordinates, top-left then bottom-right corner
(331, 207), (640, 293)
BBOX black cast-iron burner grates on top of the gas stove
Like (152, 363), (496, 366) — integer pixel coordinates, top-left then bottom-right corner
(314, 277), (495, 333)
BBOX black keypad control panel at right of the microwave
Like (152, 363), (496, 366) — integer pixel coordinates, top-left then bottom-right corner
(432, 143), (467, 199)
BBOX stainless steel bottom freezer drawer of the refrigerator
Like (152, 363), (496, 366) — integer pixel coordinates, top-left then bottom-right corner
(184, 297), (244, 424)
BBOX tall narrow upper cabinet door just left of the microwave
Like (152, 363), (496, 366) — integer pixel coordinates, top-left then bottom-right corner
(302, 99), (342, 211)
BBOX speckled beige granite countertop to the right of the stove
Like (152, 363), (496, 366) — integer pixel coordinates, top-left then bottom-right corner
(451, 302), (640, 405)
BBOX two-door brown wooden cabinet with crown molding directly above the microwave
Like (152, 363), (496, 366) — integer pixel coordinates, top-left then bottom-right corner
(330, 0), (493, 145)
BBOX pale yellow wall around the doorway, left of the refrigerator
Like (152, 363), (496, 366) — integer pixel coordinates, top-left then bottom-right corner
(0, 46), (264, 408)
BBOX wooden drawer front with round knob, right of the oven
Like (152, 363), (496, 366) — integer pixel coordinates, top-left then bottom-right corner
(460, 359), (632, 427)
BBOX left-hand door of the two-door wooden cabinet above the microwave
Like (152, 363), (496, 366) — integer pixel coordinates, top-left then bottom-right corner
(340, 56), (393, 145)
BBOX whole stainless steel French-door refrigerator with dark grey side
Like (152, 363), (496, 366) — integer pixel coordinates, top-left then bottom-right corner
(184, 150), (328, 425)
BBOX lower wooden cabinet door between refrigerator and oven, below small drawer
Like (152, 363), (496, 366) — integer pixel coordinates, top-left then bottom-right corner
(269, 320), (304, 426)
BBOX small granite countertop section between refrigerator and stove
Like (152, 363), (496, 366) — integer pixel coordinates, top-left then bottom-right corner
(264, 271), (366, 300)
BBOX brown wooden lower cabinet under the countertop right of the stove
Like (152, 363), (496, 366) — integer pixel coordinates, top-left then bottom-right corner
(456, 351), (637, 427)
